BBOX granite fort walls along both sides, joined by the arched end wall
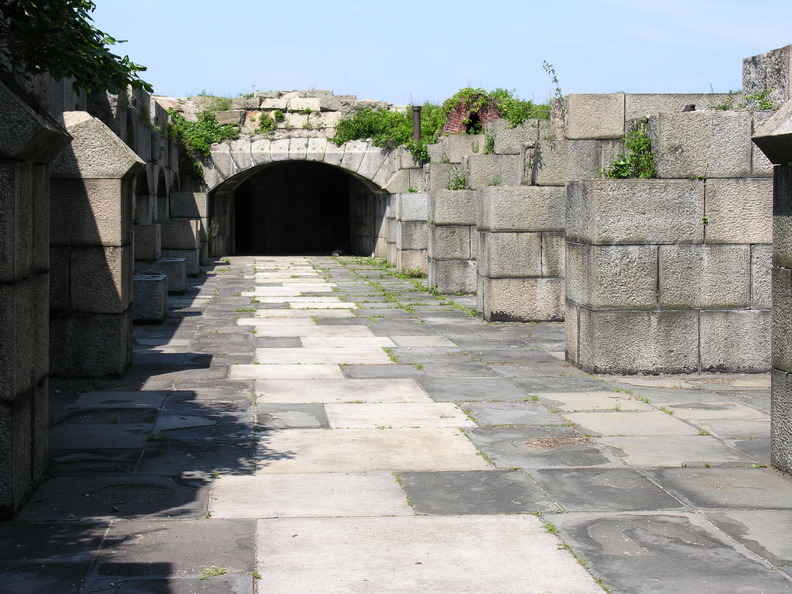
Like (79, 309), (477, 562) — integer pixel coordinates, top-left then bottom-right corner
(0, 47), (792, 516)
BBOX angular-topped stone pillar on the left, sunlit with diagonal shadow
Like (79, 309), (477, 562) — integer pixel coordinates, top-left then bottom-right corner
(50, 111), (145, 377)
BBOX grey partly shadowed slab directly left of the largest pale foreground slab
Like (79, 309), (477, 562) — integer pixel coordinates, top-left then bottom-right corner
(90, 519), (256, 580)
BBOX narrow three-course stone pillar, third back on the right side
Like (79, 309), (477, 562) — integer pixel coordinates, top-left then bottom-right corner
(427, 190), (478, 294)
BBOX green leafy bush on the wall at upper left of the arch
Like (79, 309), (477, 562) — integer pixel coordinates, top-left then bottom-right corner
(168, 109), (239, 179)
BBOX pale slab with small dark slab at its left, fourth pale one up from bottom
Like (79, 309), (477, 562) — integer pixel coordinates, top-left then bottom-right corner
(325, 402), (476, 429)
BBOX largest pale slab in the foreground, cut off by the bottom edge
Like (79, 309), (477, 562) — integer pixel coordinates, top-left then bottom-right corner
(258, 515), (602, 594)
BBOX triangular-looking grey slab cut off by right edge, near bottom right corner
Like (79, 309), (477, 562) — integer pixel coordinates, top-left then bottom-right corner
(702, 510), (792, 576)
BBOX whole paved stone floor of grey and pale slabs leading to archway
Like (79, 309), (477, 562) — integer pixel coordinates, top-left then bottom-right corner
(0, 257), (792, 594)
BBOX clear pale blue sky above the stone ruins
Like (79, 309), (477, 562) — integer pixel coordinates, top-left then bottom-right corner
(93, 0), (792, 104)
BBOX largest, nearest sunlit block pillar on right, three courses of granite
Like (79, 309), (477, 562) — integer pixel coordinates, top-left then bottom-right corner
(566, 179), (770, 373)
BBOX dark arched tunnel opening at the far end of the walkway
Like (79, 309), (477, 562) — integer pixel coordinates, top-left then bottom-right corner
(214, 161), (387, 256)
